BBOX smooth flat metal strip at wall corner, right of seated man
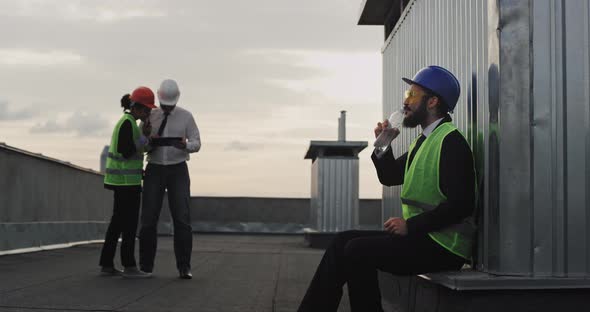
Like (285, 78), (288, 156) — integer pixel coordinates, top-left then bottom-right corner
(488, 1), (534, 275)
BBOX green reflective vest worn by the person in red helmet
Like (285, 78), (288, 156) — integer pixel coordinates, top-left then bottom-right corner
(104, 114), (143, 186)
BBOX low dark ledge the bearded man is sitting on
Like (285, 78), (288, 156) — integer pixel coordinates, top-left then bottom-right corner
(379, 272), (590, 312)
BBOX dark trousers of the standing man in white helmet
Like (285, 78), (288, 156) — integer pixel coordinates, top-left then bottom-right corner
(139, 162), (193, 272)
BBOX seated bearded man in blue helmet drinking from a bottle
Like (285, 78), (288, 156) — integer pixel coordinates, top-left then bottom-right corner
(299, 66), (476, 312)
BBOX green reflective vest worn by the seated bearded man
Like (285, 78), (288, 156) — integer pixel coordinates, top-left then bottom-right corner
(401, 122), (475, 260)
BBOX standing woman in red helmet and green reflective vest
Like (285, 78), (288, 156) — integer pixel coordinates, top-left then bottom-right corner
(99, 87), (156, 277)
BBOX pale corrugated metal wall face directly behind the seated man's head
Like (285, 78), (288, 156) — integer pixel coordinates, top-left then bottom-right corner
(383, 0), (488, 245)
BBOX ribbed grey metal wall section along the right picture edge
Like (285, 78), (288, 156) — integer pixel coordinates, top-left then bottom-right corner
(523, 0), (590, 277)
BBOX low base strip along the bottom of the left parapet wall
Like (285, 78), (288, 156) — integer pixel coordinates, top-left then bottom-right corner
(0, 221), (108, 251)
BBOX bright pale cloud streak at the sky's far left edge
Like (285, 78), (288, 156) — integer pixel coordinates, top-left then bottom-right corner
(0, 49), (84, 66)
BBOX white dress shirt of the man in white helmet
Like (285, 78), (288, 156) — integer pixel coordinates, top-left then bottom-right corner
(146, 106), (201, 165)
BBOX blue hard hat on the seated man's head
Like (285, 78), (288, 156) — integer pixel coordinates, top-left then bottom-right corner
(402, 65), (461, 112)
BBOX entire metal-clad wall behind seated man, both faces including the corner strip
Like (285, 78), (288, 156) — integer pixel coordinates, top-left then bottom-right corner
(383, 0), (590, 277)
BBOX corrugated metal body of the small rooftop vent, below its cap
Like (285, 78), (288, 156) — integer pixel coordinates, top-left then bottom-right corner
(311, 157), (359, 232)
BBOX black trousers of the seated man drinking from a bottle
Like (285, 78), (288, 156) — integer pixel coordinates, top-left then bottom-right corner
(298, 231), (465, 312)
